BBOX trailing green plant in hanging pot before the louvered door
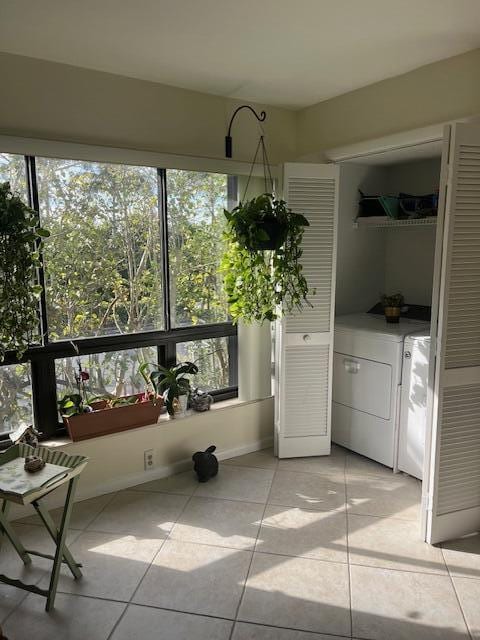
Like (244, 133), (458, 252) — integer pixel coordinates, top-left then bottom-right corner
(221, 193), (309, 323)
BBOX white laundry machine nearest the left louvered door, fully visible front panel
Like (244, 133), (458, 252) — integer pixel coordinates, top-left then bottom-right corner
(332, 313), (429, 469)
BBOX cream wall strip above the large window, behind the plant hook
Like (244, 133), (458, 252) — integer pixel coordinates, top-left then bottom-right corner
(0, 52), (298, 163)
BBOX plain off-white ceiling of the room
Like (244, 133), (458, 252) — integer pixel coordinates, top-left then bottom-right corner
(0, 0), (480, 109)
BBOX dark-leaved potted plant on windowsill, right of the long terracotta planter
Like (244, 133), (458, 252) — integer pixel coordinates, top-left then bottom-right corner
(139, 362), (198, 416)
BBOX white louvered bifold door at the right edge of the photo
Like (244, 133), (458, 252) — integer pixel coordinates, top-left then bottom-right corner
(424, 123), (480, 543)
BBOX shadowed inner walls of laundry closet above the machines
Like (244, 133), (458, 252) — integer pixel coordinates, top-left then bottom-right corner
(336, 159), (440, 315)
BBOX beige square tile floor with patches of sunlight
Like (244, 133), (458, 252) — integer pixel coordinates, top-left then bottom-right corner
(0, 447), (480, 640)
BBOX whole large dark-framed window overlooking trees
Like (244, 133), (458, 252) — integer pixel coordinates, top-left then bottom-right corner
(0, 154), (237, 439)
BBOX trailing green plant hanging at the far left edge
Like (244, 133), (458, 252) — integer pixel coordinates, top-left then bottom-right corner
(0, 182), (50, 362)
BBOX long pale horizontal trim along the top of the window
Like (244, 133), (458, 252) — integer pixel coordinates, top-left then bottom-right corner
(0, 135), (278, 176)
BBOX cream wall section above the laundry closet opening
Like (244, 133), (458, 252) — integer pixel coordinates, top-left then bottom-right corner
(297, 43), (480, 157)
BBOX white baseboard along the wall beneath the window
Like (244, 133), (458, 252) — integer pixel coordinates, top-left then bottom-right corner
(10, 437), (273, 520)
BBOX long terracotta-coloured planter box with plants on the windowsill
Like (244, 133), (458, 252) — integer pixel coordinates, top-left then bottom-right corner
(58, 359), (163, 442)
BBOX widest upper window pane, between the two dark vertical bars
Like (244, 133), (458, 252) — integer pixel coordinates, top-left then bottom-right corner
(36, 158), (164, 340)
